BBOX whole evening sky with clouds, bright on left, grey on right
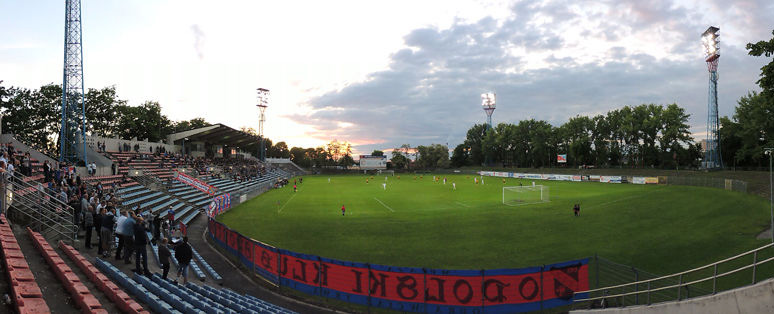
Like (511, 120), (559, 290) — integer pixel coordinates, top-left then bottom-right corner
(0, 0), (774, 153)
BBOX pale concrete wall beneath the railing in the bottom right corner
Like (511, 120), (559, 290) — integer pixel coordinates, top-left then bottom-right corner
(571, 278), (774, 314)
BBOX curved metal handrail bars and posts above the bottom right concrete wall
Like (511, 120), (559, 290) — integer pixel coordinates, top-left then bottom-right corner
(574, 243), (774, 304)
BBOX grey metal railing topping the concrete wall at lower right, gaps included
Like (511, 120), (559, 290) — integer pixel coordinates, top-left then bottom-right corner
(573, 243), (774, 309)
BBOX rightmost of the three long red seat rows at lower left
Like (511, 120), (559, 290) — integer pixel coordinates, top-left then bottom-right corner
(59, 240), (148, 314)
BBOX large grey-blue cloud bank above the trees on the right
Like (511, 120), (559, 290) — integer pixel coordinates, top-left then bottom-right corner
(291, 0), (774, 152)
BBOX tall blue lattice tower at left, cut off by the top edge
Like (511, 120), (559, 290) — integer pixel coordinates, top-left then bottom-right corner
(59, 0), (88, 163)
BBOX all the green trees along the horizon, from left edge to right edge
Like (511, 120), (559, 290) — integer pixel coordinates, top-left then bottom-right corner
(0, 31), (774, 169)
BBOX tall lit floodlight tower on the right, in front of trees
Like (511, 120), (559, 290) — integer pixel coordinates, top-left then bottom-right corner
(701, 26), (723, 169)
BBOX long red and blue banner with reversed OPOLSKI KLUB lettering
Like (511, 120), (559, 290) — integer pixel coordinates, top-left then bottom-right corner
(209, 219), (589, 313)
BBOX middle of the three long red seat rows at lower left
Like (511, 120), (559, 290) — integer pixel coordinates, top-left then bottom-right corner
(27, 227), (108, 314)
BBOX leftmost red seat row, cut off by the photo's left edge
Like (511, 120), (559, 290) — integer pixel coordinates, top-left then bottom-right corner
(0, 215), (51, 314)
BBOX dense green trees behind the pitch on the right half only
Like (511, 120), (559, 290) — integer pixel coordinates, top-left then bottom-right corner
(391, 31), (774, 168)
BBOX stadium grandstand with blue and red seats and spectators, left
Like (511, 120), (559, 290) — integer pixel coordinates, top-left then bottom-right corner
(0, 124), (318, 313)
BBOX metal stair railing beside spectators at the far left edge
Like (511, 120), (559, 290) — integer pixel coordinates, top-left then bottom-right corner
(0, 173), (78, 244)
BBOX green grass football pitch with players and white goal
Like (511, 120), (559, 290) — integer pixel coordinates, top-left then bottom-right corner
(218, 174), (769, 274)
